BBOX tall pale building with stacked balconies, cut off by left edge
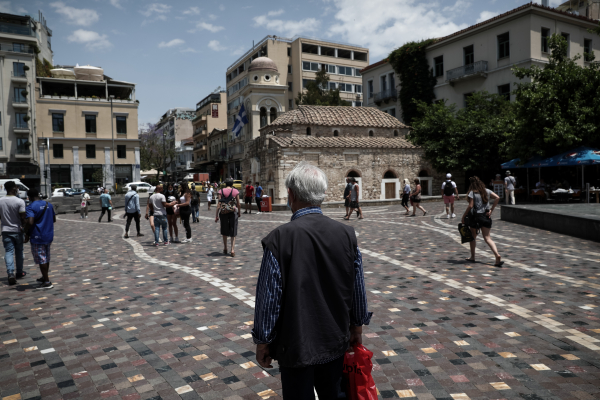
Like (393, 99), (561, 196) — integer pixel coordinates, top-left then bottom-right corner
(0, 13), (52, 187)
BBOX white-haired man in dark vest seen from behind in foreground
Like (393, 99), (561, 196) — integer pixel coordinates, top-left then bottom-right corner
(252, 163), (372, 399)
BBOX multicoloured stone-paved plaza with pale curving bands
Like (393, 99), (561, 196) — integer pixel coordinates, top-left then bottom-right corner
(0, 202), (600, 400)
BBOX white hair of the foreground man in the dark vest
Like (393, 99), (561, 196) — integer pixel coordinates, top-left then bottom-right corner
(285, 162), (327, 206)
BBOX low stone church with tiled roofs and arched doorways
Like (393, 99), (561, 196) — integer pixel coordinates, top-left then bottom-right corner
(244, 106), (458, 204)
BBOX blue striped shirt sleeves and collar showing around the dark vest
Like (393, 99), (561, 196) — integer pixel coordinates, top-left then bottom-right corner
(252, 207), (373, 344)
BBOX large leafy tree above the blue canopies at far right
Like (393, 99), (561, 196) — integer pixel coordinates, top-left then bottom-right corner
(508, 35), (600, 160)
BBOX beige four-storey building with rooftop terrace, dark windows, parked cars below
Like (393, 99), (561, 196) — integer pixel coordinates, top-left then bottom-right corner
(35, 66), (140, 193)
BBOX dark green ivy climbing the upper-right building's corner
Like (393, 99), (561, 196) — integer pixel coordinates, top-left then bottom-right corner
(388, 39), (437, 125)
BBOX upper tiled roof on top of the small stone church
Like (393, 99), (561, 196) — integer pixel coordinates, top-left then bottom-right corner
(261, 106), (409, 130)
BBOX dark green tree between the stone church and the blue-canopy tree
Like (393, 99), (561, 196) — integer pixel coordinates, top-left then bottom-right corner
(408, 92), (511, 175)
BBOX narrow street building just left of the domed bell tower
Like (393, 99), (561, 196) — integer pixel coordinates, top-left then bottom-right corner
(192, 90), (227, 172)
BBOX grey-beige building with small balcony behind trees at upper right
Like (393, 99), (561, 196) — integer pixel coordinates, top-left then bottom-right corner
(361, 3), (600, 120)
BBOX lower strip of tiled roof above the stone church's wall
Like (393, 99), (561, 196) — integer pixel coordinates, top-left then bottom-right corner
(269, 136), (419, 149)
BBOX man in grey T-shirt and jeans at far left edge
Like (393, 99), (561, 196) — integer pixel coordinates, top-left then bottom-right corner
(0, 181), (27, 285)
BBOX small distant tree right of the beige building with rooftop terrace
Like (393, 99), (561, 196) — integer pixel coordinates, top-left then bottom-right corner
(139, 124), (175, 180)
